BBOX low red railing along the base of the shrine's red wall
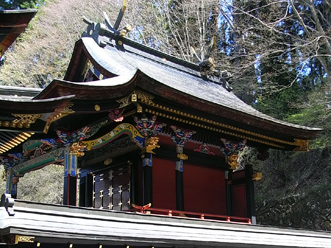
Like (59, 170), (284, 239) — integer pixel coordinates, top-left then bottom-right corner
(128, 204), (251, 224)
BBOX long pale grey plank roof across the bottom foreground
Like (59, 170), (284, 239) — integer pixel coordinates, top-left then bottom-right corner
(0, 200), (331, 248)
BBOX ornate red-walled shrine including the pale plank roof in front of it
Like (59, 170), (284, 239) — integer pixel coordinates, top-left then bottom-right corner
(0, 5), (331, 248)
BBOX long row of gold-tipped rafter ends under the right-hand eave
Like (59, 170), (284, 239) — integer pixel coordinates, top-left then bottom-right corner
(146, 109), (286, 149)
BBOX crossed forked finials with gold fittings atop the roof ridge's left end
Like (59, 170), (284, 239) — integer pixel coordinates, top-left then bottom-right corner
(82, 0), (132, 47)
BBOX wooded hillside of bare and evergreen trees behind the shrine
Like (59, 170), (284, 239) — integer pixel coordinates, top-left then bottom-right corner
(0, 0), (331, 230)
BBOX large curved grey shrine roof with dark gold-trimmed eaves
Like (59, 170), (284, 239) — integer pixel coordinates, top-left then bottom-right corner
(0, 11), (322, 155)
